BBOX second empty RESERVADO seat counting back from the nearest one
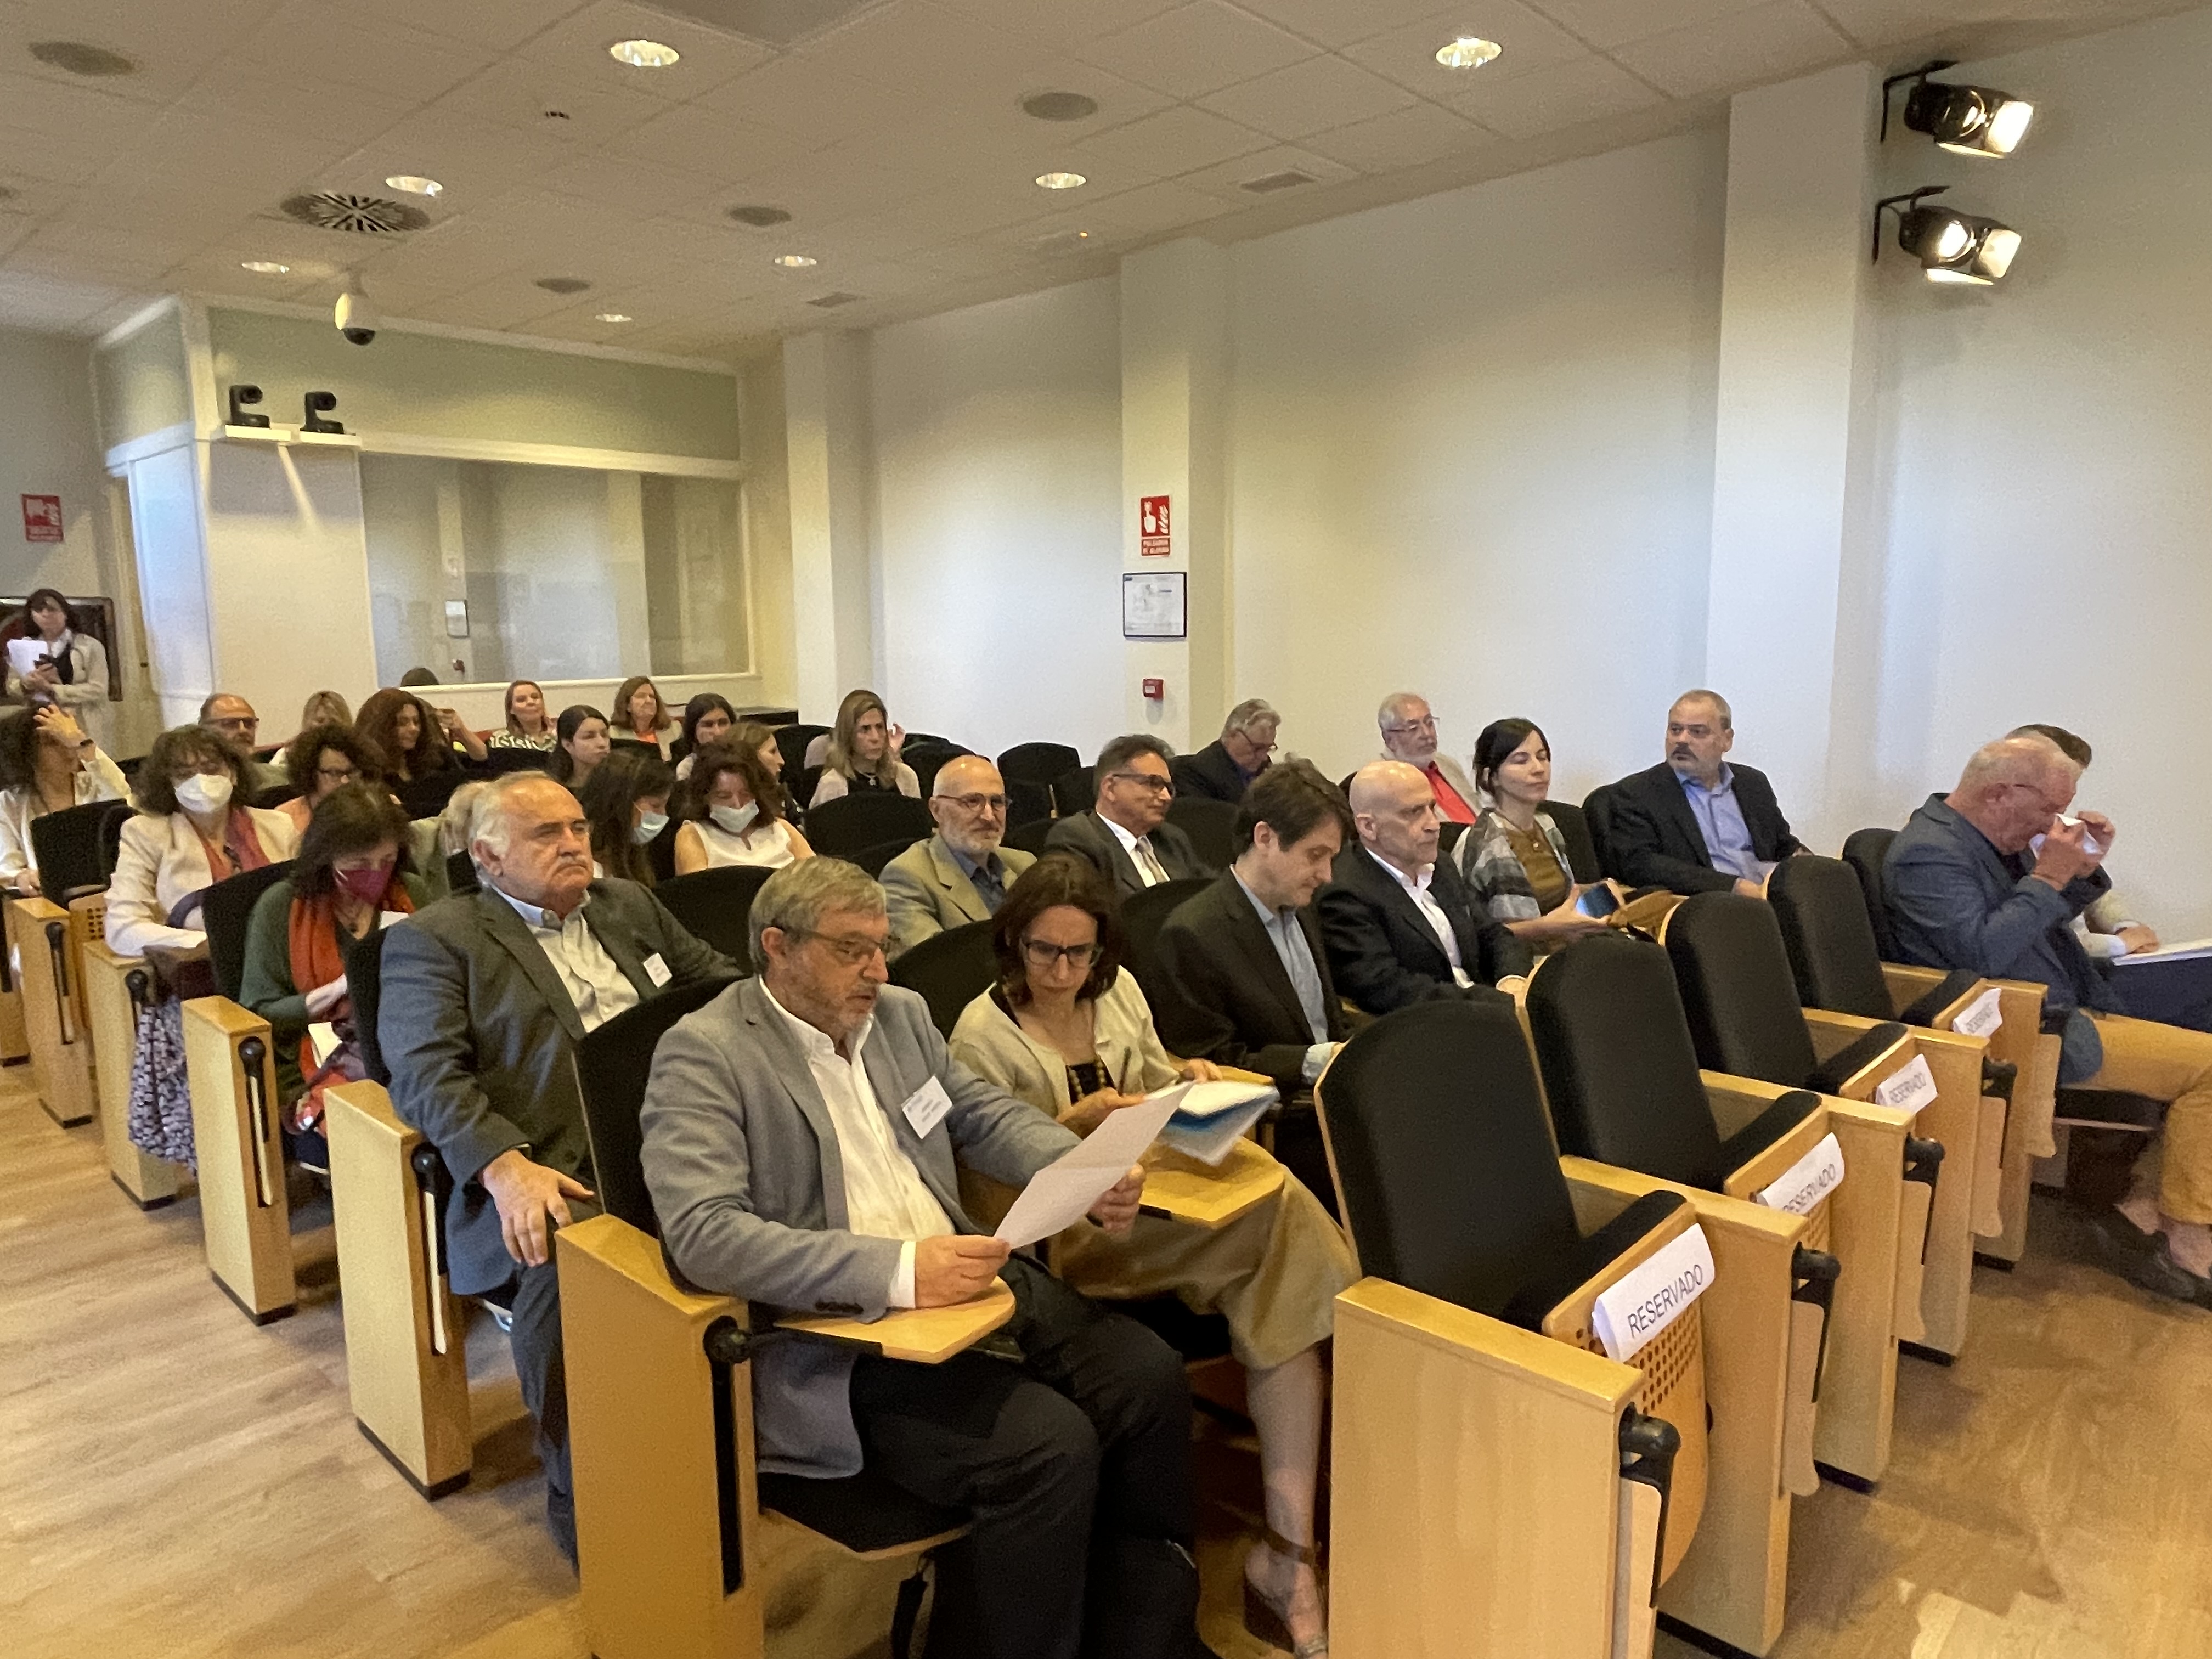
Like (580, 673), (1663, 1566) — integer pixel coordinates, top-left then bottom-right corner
(1524, 934), (1942, 1495)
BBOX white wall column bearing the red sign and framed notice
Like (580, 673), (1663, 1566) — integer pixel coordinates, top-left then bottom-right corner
(1121, 239), (1234, 752)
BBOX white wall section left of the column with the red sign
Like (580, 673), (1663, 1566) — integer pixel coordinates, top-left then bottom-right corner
(871, 276), (1124, 754)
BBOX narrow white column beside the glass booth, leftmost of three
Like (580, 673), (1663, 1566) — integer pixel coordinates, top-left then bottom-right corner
(783, 334), (876, 723)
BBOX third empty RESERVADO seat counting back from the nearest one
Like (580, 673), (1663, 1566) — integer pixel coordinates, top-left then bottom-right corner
(1659, 891), (2002, 1358)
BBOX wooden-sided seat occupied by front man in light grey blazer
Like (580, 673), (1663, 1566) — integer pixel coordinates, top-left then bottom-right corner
(555, 982), (1013, 1659)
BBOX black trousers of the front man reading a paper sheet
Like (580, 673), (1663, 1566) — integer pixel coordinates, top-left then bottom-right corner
(851, 1256), (1199, 1659)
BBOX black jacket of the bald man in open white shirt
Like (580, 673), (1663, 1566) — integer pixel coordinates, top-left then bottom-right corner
(1314, 840), (1535, 1013)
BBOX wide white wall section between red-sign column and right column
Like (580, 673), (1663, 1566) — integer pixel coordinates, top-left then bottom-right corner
(1229, 131), (1725, 797)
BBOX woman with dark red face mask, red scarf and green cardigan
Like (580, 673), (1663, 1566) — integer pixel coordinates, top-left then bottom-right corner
(241, 783), (427, 1172)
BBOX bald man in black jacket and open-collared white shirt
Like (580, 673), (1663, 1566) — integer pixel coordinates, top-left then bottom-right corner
(1316, 761), (1535, 1013)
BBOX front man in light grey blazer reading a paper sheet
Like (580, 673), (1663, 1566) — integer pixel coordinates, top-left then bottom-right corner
(644, 858), (1201, 1659)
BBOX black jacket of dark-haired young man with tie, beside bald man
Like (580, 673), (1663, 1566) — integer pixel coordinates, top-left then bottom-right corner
(1153, 870), (1350, 1102)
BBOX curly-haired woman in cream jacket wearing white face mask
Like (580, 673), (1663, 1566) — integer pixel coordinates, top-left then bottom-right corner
(109, 725), (298, 956)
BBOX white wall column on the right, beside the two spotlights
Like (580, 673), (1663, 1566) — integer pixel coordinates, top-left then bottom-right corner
(1706, 64), (1880, 851)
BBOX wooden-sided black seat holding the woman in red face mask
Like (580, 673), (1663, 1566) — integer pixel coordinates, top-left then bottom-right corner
(184, 860), (296, 1325)
